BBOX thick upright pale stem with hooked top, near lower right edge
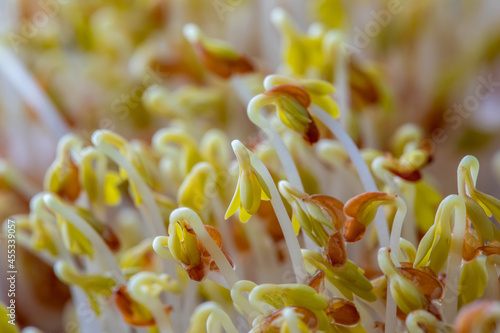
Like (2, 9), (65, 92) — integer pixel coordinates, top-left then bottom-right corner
(441, 195), (467, 324)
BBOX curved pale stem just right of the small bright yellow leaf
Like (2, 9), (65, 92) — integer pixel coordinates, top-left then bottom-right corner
(92, 135), (167, 235)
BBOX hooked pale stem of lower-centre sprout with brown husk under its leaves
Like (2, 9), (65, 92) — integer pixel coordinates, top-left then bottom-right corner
(170, 207), (239, 289)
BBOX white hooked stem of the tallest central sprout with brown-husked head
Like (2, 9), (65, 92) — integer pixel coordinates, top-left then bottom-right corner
(247, 94), (304, 192)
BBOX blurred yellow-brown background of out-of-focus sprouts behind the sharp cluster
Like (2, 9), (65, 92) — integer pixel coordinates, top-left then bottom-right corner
(0, 0), (500, 331)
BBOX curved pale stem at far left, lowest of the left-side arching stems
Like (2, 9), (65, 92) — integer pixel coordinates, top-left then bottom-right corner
(43, 193), (126, 284)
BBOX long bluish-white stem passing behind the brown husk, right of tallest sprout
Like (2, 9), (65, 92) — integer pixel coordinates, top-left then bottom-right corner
(311, 106), (389, 247)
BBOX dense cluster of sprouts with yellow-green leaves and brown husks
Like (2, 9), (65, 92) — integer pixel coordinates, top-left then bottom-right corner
(0, 1), (500, 333)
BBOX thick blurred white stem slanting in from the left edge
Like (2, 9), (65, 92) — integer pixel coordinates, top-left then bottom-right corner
(0, 45), (69, 139)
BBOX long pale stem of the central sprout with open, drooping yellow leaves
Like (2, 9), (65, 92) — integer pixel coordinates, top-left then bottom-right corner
(246, 147), (307, 283)
